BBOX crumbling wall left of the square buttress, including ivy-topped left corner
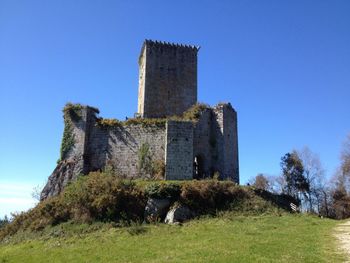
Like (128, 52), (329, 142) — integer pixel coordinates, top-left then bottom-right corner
(41, 106), (165, 199)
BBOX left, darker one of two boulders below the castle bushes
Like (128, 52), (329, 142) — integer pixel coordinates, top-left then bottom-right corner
(144, 198), (170, 222)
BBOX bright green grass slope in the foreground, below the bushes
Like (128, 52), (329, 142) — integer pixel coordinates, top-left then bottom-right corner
(0, 213), (344, 262)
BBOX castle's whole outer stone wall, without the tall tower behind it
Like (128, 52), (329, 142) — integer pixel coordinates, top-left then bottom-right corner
(41, 104), (239, 199)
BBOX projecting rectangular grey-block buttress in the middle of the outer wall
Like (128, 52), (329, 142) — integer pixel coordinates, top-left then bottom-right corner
(165, 121), (193, 180)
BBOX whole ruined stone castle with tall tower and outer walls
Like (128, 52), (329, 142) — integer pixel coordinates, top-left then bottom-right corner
(41, 40), (239, 200)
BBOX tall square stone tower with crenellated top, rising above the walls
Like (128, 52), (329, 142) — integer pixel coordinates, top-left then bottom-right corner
(138, 40), (199, 118)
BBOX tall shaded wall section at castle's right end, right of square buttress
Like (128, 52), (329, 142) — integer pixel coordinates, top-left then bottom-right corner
(193, 103), (239, 183)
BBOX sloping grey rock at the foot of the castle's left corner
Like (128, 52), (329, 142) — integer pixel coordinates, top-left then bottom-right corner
(40, 161), (83, 201)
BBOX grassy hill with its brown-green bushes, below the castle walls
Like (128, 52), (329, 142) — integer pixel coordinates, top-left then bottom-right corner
(0, 173), (344, 263)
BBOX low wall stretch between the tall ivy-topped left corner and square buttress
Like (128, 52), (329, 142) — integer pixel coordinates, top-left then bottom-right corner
(88, 124), (165, 178)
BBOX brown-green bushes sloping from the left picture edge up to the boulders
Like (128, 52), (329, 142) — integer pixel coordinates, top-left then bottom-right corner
(0, 172), (147, 240)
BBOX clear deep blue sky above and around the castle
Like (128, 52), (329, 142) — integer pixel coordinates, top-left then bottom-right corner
(0, 0), (350, 216)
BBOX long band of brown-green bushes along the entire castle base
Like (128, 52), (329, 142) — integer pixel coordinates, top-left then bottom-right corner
(0, 176), (291, 241)
